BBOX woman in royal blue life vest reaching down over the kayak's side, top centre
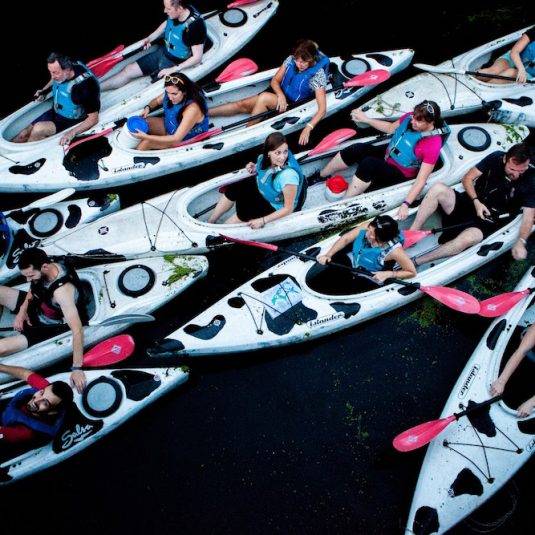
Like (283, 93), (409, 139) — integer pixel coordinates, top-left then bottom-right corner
(209, 39), (330, 145)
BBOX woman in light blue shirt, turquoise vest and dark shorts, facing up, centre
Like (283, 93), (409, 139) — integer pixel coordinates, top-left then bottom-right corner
(208, 132), (306, 229)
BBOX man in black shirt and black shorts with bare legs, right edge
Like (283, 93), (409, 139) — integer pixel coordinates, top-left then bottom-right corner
(411, 143), (535, 266)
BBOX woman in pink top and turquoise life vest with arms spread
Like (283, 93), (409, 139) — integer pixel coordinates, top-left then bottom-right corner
(320, 100), (449, 219)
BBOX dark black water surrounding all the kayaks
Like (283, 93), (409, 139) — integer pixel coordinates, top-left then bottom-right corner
(0, 0), (534, 534)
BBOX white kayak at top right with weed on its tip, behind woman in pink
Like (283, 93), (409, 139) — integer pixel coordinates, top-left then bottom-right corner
(363, 28), (532, 120)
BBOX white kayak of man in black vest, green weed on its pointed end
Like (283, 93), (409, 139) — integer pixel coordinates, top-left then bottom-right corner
(0, 255), (208, 383)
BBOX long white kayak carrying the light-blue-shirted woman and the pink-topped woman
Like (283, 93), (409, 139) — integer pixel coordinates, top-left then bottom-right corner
(42, 124), (529, 258)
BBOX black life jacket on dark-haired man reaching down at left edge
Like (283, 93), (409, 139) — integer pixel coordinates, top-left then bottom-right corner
(30, 261), (88, 325)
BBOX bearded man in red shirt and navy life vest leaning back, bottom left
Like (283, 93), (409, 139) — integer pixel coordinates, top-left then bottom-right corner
(0, 364), (73, 446)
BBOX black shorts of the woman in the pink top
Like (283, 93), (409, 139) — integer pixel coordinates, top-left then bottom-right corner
(340, 143), (409, 188)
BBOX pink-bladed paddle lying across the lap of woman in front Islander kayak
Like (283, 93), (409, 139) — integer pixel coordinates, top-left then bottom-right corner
(220, 234), (479, 314)
